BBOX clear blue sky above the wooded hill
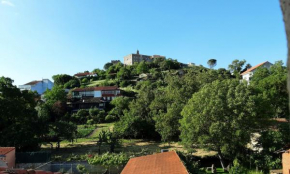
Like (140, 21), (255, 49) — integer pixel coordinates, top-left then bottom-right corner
(0, 0), (287, 85)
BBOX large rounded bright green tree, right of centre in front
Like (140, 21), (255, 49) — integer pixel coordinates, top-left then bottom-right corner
(180, 80), (261, 168)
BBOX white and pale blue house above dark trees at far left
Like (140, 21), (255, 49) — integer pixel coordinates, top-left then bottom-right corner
(18, 79), (54, 95)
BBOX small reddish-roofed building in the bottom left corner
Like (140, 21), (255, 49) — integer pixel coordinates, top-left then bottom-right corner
(0, 147), (15, 169)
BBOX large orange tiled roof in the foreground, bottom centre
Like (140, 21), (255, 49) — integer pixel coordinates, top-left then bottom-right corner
(121, 151), (188, 174)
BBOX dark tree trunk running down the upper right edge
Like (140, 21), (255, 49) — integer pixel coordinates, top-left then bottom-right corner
(280, 0), (290, 119)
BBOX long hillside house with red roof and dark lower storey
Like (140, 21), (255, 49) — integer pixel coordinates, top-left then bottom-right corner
(68, 86), (122, 111)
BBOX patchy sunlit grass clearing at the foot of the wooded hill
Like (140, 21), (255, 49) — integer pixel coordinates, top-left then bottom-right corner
(42, 123), (216, 161)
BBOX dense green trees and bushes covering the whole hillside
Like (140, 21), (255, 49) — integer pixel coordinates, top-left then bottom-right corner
(0, 58), (290, 172)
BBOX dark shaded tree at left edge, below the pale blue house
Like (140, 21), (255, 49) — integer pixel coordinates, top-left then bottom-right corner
(0, 77), (42, 151)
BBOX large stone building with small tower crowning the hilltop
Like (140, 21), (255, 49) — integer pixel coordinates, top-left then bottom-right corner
(124, 50), (165, 65)
